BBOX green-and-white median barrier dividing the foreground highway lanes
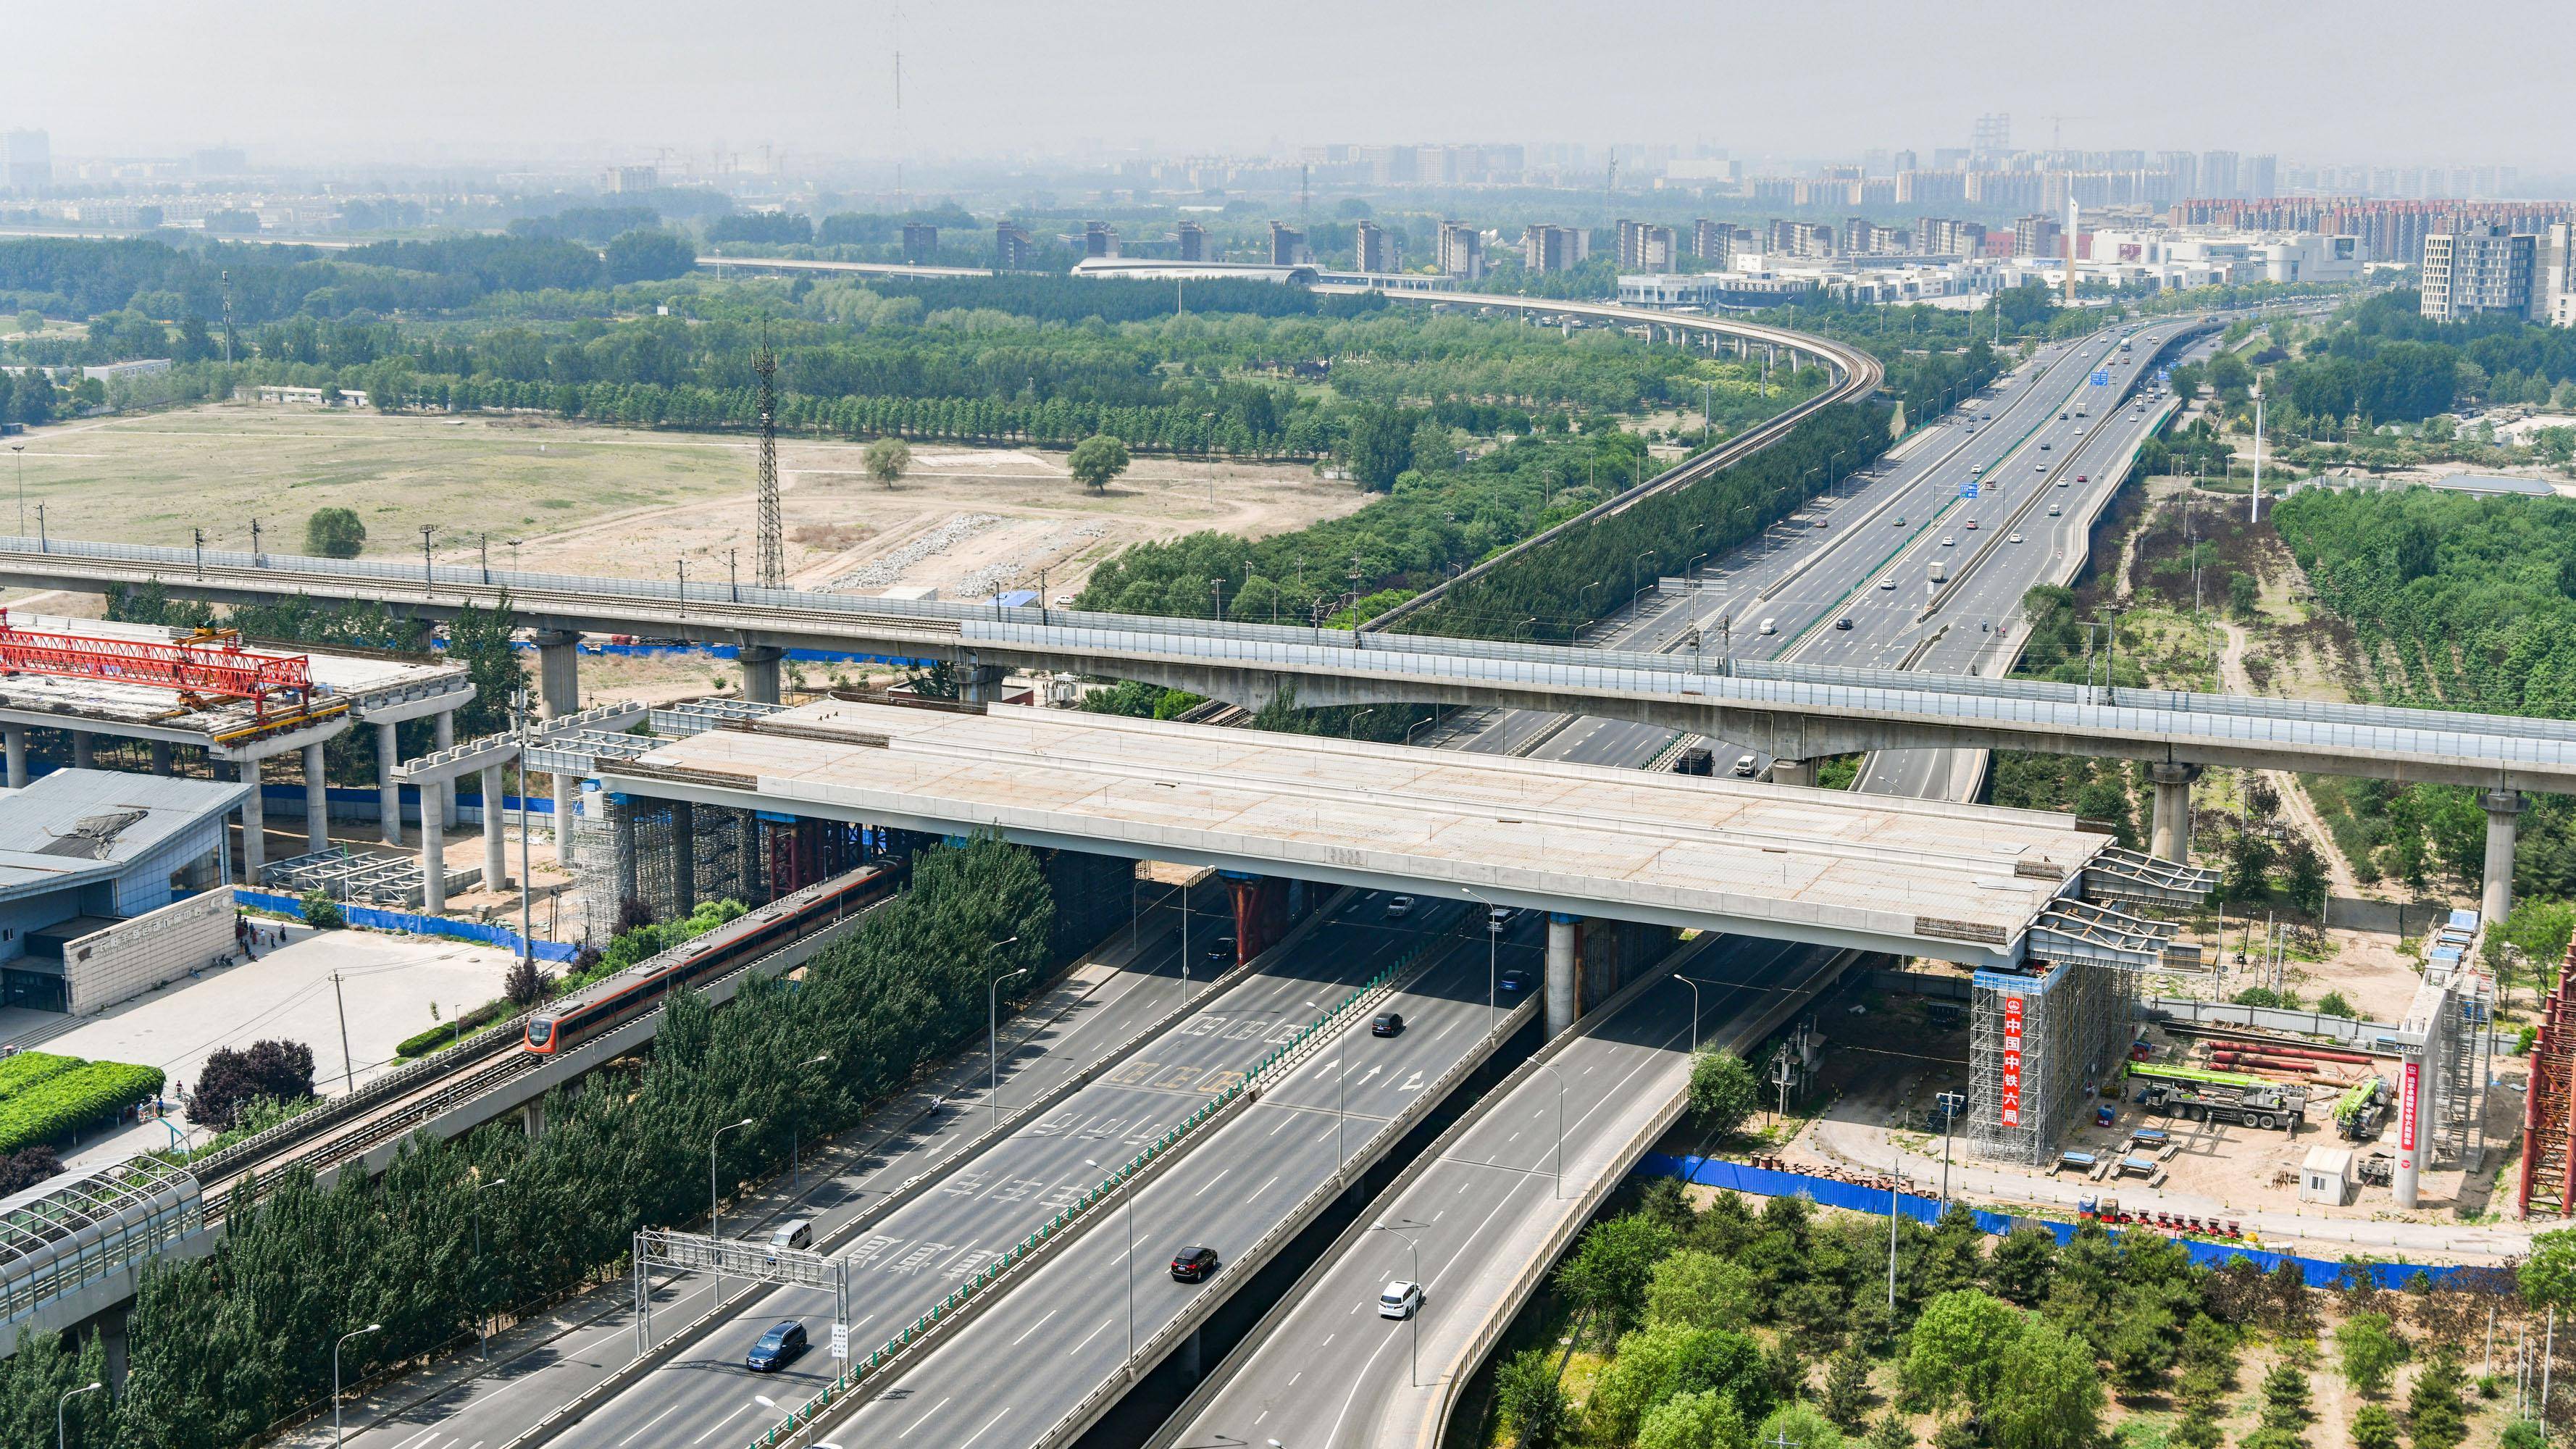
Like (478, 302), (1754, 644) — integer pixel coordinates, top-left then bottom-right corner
(750, 923), (1435, 1449)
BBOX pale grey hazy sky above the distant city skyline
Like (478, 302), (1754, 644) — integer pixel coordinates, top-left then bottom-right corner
(20, 0), (2576, 172)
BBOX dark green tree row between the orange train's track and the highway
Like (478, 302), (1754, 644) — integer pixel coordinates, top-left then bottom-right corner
(0, 840), (1053, 1449)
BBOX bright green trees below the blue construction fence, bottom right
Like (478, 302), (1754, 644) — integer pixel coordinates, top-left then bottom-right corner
(1497, 1181), (2545, 1449)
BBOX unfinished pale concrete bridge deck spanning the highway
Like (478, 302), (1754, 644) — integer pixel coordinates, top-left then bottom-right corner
(598, 698), (2109, 969)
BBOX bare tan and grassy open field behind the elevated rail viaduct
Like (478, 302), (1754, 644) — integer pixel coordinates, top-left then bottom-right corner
(4, 402), (1368, 598)
